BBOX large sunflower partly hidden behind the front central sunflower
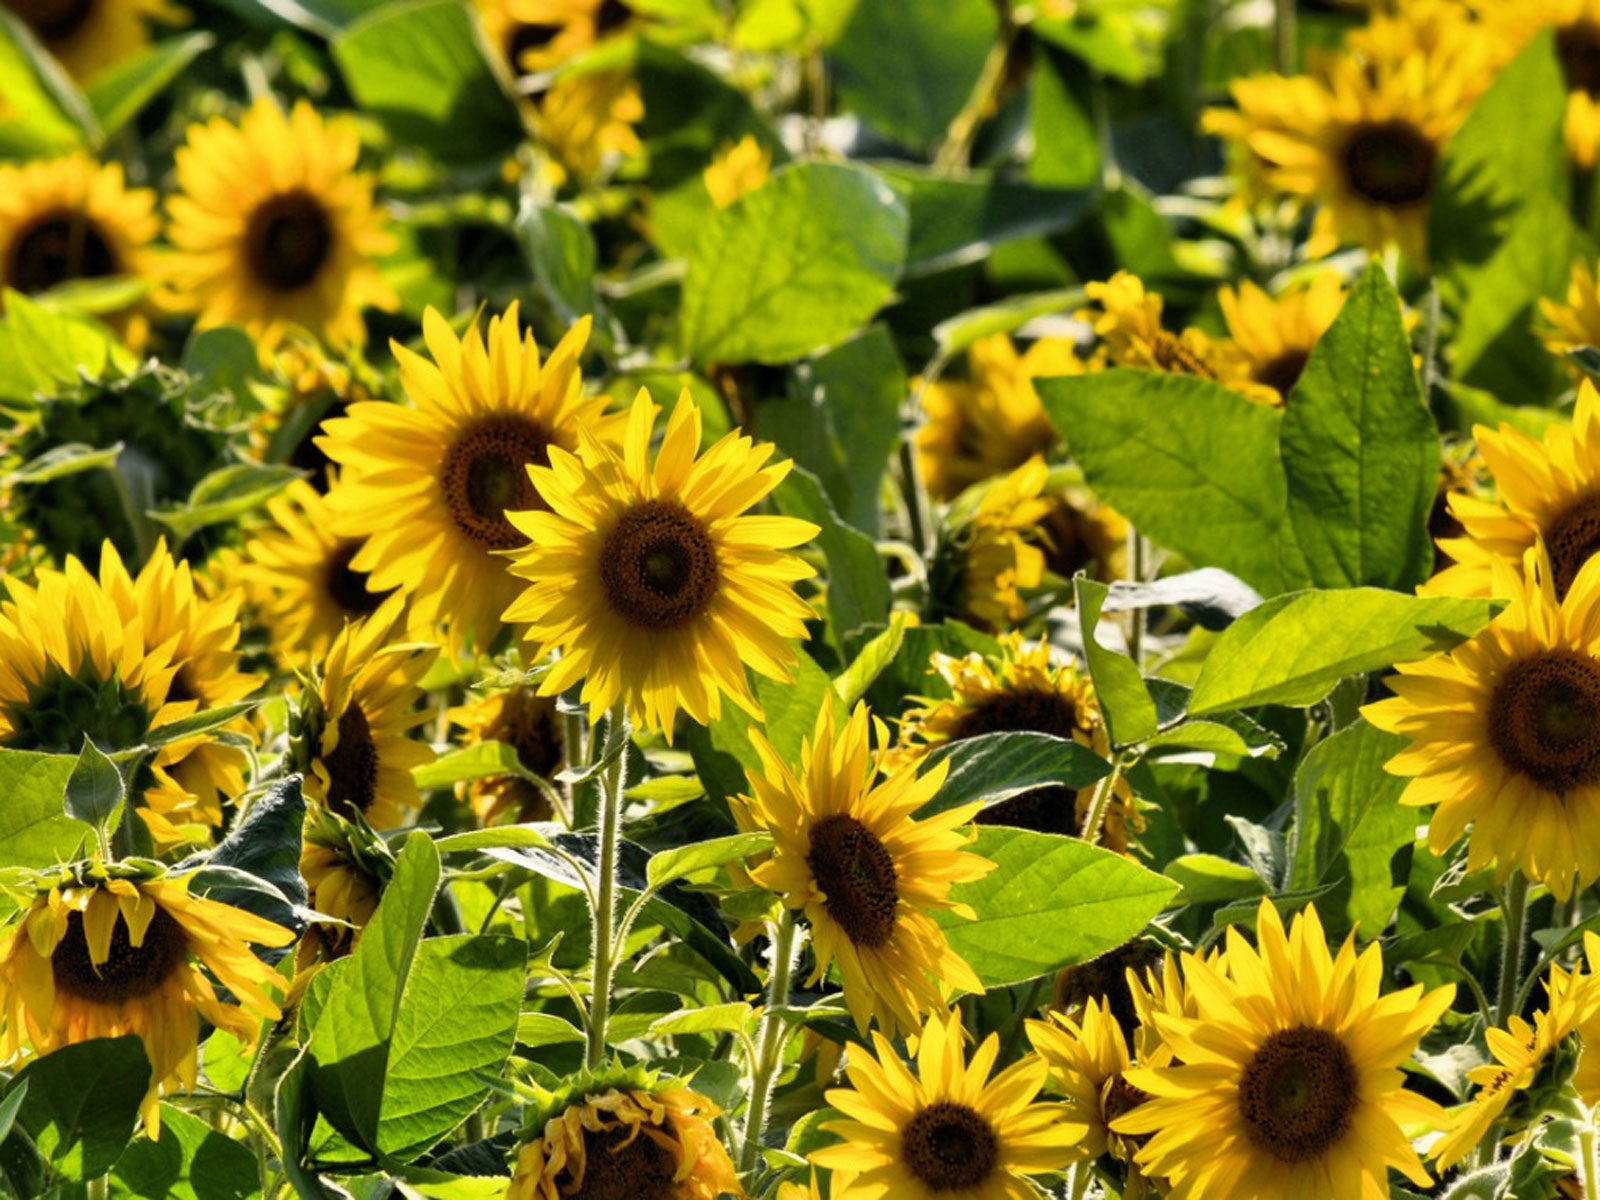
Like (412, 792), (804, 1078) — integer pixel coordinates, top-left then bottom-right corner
(317, 302), (606, 651)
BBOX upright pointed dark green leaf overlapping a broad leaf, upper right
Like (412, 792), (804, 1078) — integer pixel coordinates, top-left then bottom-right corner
(1282, 262), (1438, 590)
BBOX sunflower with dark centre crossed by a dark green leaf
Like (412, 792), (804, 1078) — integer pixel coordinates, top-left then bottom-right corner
(898, 632), (1141, 853)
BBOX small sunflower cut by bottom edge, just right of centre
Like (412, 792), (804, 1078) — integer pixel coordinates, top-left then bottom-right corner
(811, 1011), (1085, 1200)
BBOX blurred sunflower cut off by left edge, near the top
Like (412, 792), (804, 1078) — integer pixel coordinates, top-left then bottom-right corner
(0, 155), (162, 333)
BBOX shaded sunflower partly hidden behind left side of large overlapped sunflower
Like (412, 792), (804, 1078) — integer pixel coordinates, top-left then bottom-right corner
(237, 480), (394, 666)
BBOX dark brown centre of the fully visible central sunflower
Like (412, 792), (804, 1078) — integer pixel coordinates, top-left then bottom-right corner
(600, 501), (722, 630)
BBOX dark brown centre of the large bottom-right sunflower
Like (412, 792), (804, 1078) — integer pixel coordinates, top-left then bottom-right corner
(1238, 1026), (1360, 1163)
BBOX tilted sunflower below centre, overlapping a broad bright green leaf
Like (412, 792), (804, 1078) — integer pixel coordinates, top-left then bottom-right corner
(734, 704), (994, 1034)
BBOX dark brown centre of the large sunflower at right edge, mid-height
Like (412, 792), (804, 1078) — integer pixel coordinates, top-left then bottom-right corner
(1490, 650), (1600, 792)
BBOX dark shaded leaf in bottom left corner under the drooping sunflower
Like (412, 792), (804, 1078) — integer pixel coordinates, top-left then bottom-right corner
(11, 1034), (150, 1179)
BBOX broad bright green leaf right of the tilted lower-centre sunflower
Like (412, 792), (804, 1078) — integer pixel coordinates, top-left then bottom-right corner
(934, 826), (1178, 987)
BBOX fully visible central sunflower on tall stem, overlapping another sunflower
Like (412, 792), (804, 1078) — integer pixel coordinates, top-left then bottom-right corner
(506, 390), (818, 739)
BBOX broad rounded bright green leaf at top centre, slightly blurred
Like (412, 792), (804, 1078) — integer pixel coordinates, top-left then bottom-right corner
(682, 162), (907, 363)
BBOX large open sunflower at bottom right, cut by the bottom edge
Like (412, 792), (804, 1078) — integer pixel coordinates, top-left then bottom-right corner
(1112, 899), (1454, 1200)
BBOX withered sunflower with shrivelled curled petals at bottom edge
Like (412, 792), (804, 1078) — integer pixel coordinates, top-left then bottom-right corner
(506, 1085), (744, 1200)
